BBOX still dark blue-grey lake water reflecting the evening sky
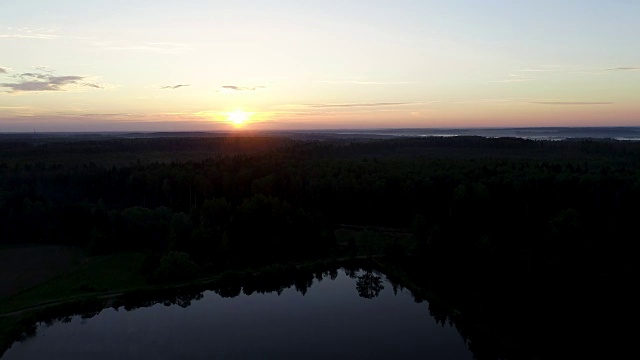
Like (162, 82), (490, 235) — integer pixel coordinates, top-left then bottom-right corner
(2, 269), (473, 360)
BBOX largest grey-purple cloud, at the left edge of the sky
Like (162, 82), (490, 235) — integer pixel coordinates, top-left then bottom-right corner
(0, 73), (102, 93)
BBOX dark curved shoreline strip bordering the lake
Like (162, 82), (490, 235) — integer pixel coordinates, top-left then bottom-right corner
(0, 255), (536, 360)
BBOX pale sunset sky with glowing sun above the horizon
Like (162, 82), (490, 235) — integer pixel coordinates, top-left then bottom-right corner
(0, 0), (640, 132)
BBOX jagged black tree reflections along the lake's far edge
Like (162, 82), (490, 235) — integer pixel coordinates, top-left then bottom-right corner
(0, 266), (532, 360)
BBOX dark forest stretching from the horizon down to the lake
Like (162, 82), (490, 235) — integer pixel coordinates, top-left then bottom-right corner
(0, 134), (640, 357)
